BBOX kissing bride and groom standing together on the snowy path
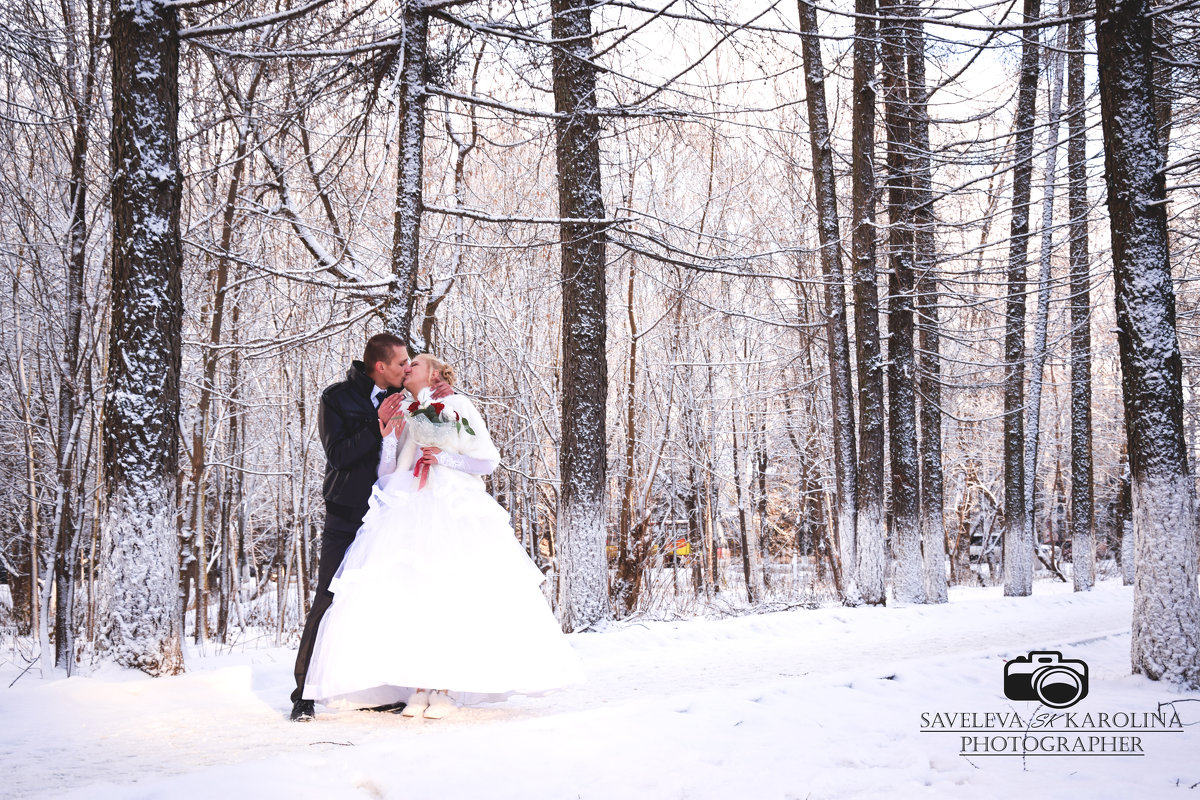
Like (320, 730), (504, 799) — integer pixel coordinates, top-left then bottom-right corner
(292, 333), (583, 721)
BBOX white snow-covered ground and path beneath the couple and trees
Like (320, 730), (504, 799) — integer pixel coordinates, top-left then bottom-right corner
(0, 582), (1200, 800)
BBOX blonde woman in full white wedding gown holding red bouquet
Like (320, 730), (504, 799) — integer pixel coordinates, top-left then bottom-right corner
(304, 354), (583, 718)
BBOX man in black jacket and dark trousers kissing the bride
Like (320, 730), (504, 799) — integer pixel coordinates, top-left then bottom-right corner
(292, 333), (452, 722)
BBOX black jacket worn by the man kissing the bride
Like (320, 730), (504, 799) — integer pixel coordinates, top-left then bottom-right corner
(317, 361), (393, 524)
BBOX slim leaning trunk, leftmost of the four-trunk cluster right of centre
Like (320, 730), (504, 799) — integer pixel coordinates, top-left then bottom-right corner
(798, 0), (862, 603)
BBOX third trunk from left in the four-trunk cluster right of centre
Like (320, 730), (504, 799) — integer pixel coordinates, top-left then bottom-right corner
(880, 0), (925, 603)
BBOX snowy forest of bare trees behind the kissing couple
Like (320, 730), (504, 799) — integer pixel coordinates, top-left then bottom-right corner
(0, 0), (1200, 682)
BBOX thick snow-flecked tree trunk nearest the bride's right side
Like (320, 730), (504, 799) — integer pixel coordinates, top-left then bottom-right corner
(551, 0), (610, 631)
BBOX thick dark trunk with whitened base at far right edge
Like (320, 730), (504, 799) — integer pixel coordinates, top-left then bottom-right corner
(1096, 0), (1200, 688)
